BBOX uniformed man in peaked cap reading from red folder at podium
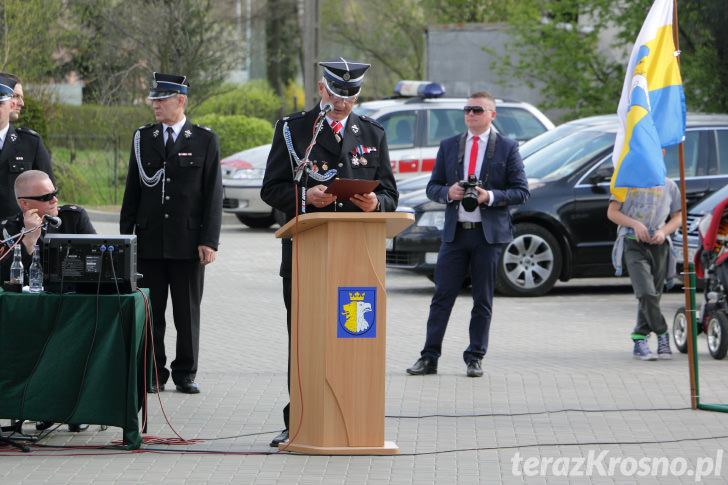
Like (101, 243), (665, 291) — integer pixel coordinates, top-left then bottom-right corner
(260, 58), (399, 447)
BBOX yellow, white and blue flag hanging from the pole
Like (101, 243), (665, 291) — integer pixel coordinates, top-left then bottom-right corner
(611, 0), (685, 201)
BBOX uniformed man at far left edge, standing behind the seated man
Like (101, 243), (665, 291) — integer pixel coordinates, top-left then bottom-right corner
(0, 76), (54, 217)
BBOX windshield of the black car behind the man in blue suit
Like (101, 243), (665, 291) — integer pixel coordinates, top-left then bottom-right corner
(523, 130), (615, 180)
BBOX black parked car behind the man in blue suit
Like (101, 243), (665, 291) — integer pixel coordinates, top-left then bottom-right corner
(387, 114), (728, 296)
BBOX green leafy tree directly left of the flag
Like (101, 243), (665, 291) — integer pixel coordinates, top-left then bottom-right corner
(490, 0), (624, 118)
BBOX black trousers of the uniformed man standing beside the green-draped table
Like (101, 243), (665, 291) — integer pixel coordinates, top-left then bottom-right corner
(138, 259), (205, 383)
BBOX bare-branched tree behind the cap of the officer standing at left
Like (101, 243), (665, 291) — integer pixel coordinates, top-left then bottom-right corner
(68, 0), (242, 104)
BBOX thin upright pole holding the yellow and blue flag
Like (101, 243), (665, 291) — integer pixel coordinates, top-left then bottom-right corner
(672, 0), (698, 409)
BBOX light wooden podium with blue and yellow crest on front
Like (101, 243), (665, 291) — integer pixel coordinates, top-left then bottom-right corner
(276, 212), (414, 455)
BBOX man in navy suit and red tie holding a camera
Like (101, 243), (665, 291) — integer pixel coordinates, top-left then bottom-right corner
(407, 92), (529, 377)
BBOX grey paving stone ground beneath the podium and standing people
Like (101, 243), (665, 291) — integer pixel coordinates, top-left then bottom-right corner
(0, 214), (728, 484)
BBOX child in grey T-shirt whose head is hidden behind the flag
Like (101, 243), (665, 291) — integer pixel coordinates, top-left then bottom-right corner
(607, 178), (682, 360)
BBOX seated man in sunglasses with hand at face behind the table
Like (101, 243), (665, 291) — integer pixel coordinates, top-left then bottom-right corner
(0, 170), (96, 432)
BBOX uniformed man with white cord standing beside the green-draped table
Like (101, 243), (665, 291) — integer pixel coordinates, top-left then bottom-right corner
(120, 73), (222, 394)
